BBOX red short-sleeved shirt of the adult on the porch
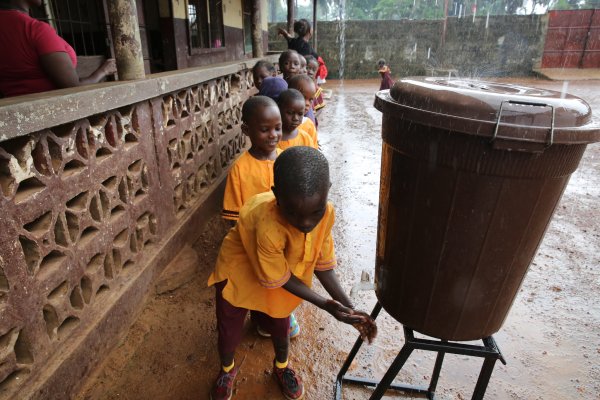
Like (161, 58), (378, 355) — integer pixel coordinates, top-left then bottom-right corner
(0, 10), (77, 97)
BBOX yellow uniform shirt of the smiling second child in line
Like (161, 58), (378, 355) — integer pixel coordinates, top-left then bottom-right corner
(221, 149), (282, 221)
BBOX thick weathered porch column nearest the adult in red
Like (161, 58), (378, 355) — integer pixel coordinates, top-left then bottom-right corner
(107, 0), (146, 81)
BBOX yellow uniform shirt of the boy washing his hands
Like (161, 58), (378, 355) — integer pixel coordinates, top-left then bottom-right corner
(208, 192), (336, 318)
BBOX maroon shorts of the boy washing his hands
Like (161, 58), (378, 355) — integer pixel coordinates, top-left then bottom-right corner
(215, 281), (290, 354)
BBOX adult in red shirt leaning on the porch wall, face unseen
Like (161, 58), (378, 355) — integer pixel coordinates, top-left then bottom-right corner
(0, 0), (116, 97)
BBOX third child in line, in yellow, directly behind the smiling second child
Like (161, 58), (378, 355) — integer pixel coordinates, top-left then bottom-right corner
(277, 89), (317, 150)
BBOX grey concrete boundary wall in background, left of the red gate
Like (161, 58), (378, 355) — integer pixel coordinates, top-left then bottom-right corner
(269, 15), (547, 78)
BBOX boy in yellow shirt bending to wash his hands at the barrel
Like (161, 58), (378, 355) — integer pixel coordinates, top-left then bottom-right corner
(208, 146), (376, 400)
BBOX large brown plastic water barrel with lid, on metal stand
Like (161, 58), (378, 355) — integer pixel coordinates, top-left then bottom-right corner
(375, 78), (600, 341)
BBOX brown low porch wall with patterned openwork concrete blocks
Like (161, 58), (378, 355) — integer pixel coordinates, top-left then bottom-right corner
(0, 55), (276, 399)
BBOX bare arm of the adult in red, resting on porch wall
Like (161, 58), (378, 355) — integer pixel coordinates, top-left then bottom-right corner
(40, 51), (116, 89)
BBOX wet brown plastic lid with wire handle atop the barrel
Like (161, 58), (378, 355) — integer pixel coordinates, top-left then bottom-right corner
(375, 77), (600, 150)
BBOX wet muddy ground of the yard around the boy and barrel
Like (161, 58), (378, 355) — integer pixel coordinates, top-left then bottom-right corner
(76, 80), (600, 400)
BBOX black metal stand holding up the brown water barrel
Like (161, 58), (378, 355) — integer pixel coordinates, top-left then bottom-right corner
(334, 302), (506, 400)
